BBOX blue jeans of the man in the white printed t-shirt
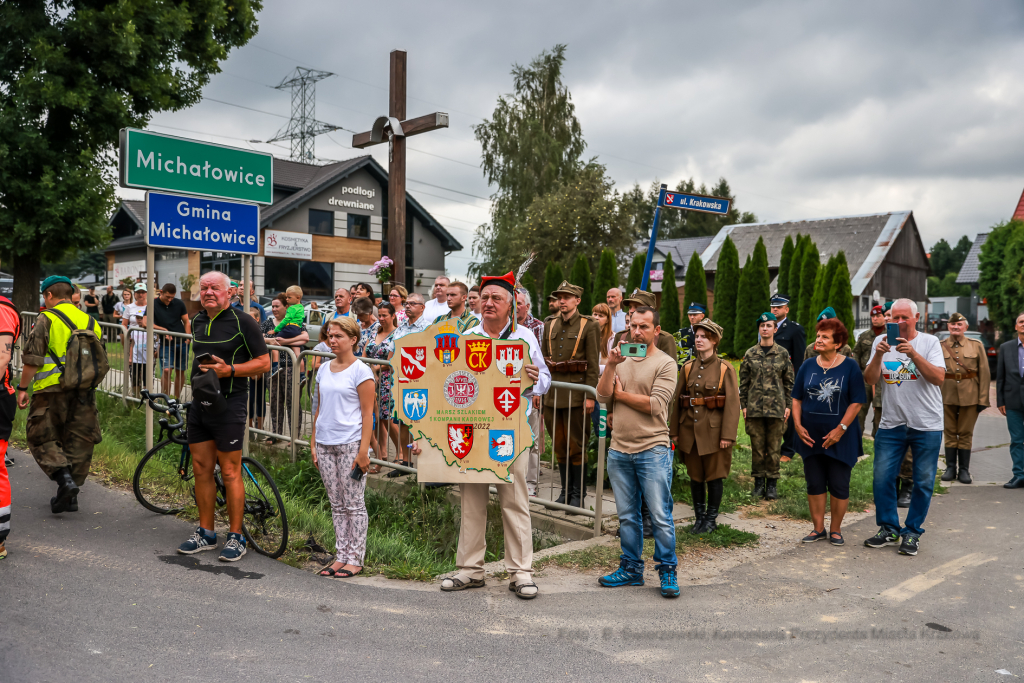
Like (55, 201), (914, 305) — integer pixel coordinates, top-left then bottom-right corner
(872, 426), (942, 537)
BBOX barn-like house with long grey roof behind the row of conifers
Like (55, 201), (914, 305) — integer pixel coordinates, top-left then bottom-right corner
(700, 211), (930, 322)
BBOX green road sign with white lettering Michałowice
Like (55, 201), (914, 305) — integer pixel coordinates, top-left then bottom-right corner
(118, 128), (273, 204)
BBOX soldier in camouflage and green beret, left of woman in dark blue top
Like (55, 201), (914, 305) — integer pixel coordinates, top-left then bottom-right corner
(739, 313), (796, 501)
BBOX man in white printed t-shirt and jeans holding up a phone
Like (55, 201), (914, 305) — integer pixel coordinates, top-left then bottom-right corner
(864, 299), (946, 555)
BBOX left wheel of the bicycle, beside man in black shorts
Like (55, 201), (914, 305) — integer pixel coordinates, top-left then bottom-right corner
(132, 439), (196, 515)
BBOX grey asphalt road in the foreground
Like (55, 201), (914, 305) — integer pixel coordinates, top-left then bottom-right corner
(0, 452), (1024, 683)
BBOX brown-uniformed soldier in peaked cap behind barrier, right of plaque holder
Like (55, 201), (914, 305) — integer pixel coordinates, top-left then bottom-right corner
(540, 281), (601, 507)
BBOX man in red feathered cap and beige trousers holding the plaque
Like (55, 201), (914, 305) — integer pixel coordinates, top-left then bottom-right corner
(413, 272), (551, 600)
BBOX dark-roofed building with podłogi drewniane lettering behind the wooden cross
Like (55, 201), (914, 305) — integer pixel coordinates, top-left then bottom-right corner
(106, 156), (462, 300)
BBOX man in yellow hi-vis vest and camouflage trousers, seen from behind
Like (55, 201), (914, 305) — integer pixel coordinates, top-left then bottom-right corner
(17, 275), (102, 514)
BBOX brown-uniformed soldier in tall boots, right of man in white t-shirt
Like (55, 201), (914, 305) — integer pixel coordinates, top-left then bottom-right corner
(941, 313), (991, 483)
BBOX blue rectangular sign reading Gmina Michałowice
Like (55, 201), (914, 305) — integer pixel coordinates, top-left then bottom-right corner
(145, 191), (259, 254)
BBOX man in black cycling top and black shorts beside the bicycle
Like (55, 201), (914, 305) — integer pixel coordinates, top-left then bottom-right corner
(178, 270), (270, 562)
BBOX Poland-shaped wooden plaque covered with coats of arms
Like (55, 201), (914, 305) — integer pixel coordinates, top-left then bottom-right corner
(391, 321), (534, 483)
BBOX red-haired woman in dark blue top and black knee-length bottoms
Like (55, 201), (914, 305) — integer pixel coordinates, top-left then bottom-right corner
(793, 317), (867, 546)
